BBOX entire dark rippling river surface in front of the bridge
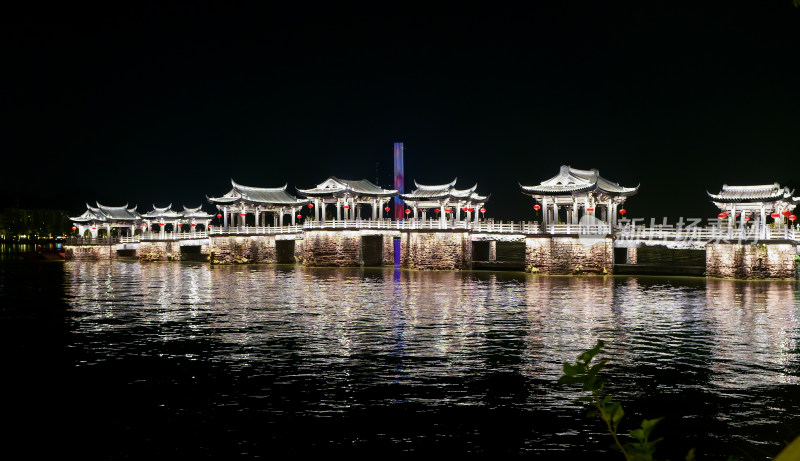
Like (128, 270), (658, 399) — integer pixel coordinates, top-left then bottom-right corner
(0, 260), (800, 459)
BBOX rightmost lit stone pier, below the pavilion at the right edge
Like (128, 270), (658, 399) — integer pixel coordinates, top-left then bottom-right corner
(706, 243), (797, 279)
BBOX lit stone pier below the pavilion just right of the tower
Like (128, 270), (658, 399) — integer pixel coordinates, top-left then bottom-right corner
(400, 231), (472, 270)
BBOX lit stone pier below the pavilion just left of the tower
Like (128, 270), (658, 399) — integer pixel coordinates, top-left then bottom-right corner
(302, 231), (361, 267)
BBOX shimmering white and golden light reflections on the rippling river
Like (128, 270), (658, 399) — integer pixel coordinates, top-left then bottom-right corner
(65, 262), (800, 457)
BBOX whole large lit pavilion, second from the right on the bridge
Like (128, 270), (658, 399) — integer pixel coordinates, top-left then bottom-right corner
(520, 165), (639, 226)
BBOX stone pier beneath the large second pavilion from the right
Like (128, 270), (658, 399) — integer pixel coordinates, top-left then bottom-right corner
(525, 237), (614, 275)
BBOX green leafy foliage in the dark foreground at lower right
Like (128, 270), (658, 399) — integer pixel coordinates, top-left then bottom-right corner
(558, 340), (800, 461)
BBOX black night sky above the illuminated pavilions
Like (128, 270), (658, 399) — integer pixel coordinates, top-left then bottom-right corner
(0, 0), (800, 219)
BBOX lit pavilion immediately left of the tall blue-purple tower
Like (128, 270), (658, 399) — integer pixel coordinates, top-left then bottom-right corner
(297, 176), (397, 221)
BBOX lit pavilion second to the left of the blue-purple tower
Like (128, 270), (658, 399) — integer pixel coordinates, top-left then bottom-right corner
(207, 180), (308, 228)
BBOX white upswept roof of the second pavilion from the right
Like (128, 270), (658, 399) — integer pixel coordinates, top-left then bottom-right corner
(520, 165), (639, 196)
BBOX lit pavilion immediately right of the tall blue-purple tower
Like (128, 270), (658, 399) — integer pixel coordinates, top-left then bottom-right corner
(400, 179), (489, 225)
